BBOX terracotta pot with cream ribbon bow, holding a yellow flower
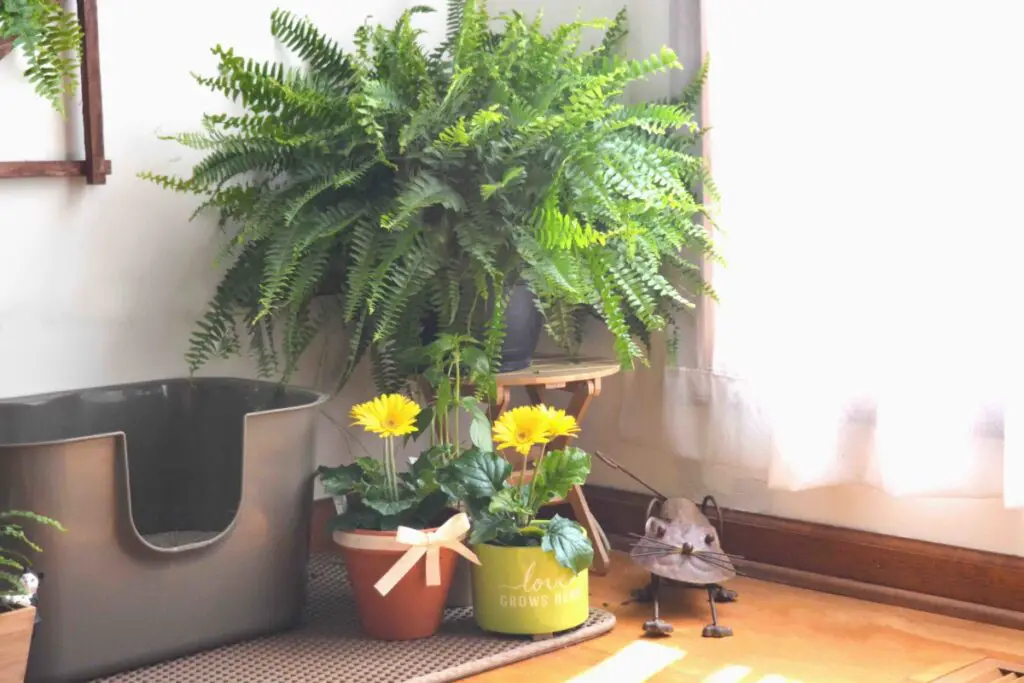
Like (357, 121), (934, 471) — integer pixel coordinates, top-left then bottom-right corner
(334, 529), (459, 640)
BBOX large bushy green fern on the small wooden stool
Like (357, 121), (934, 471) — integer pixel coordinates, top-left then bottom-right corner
(144, 0), (715, 391)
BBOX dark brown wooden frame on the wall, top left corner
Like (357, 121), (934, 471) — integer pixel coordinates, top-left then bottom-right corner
(0, 0), (111, 185)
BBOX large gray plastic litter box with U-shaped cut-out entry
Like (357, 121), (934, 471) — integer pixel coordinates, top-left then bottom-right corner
(0, 378), (326, 683)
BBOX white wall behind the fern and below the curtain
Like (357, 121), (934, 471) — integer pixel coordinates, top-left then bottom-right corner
(0, 0), (1024, 555)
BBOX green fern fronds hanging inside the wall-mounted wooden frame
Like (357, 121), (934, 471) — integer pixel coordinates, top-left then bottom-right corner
(0, 0), (82, 115)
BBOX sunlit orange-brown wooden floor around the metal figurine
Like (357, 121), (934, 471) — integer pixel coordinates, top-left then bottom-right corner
(470, 553), (1024, 683)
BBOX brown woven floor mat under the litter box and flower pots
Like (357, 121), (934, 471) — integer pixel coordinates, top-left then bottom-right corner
(92, 555), (615, 683)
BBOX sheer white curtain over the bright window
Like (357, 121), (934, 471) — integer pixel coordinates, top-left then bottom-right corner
(623, 0), (1024, 507)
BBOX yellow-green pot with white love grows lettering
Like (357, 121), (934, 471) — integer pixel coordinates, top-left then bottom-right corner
(473, 544), (590, 635)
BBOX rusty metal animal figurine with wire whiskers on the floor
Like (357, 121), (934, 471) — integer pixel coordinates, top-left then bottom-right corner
(595, 452), (739, 638)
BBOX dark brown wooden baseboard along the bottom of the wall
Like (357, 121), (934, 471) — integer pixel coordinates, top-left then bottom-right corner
(310, 485), (1024, 629)
